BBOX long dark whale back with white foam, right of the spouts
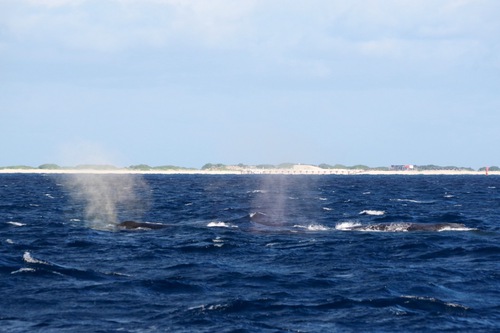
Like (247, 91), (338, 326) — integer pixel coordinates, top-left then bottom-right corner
(341, 222), (471, 232)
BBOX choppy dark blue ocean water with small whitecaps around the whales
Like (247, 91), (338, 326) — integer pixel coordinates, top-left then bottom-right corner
(0, 174), (500, 332)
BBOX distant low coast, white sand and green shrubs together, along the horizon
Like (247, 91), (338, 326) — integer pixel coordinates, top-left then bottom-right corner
(0, 163), (500, 175)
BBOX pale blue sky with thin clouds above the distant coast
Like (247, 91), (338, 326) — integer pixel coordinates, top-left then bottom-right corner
(0, 0), (500, 168)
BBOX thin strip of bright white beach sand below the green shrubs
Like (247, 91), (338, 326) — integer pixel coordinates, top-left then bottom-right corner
(0, 166), (492, 176)
